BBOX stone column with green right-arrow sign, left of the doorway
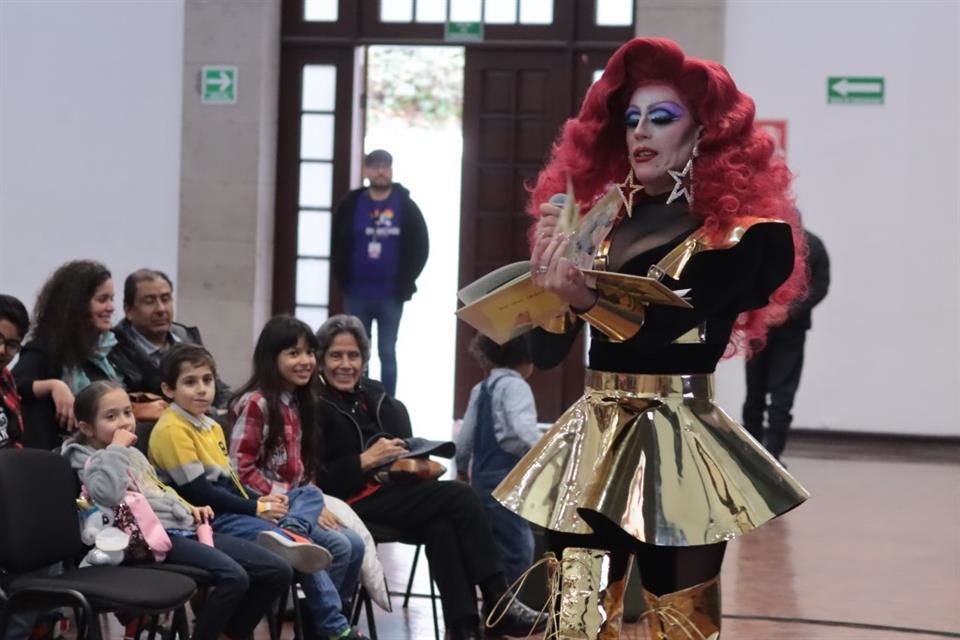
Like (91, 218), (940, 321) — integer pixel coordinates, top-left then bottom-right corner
(174, 0), (280, 385)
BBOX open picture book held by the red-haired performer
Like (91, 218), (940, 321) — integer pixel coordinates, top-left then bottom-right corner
(457, 187), (690, 344)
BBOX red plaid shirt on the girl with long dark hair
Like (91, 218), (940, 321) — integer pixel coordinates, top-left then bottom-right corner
(230, 391), (303, 495)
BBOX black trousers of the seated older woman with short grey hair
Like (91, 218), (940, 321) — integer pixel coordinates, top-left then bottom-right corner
(351, 481), (503, 625)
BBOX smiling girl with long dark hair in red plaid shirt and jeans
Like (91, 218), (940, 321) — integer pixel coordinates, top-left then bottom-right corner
(230, 316), (364, 638)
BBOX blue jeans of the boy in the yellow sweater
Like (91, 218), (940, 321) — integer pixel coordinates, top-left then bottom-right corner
(213, 485), (350, 636)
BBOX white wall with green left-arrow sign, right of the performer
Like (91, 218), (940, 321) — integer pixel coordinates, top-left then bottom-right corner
(719, 0), (960, 435)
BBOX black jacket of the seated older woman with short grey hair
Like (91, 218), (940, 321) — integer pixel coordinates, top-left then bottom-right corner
(315, 379), (413, 500)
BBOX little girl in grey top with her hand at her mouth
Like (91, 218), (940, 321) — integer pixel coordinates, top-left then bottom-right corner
(62, 381), (292, 640)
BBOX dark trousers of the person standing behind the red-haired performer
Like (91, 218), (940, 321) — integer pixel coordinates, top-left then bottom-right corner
(743, 329), (807, 459)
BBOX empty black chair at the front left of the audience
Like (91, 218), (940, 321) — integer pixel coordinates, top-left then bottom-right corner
(0, 449), (196, 640)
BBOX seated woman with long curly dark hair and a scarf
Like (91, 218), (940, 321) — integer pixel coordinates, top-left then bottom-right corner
(13, 260), (129, 449)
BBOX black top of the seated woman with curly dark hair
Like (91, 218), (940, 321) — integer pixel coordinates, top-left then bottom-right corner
(13, 339), (129, 450)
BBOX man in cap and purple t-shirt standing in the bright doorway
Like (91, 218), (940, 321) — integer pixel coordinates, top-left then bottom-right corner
(330, 149), (430, 396)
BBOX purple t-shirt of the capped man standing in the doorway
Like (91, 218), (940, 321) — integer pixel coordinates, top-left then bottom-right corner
(350, 189), (401, 298)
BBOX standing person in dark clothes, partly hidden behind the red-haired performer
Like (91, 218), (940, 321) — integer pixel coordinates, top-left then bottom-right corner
(743, 229), (830, 460)
